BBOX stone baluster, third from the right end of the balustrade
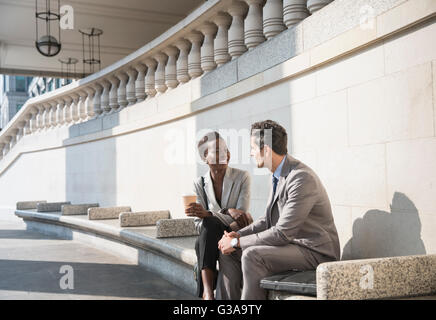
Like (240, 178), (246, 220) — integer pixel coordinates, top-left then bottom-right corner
(263, 0), (286, 40)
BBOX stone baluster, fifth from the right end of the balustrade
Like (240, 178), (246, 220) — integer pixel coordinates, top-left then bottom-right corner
(227, 1), (248, 59)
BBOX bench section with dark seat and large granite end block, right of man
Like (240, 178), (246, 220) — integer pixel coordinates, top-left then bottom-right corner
(260, 254), (436, 300)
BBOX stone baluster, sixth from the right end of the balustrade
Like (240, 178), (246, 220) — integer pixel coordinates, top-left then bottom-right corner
(212, 12), (232, 67)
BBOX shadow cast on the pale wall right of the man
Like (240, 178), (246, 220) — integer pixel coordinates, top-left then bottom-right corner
(341, 192), (426, 260)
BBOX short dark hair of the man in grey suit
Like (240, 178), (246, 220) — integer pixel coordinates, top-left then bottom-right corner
(251, 120), (288, 155)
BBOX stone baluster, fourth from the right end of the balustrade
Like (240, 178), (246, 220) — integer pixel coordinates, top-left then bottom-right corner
(244, 0), (265, 50)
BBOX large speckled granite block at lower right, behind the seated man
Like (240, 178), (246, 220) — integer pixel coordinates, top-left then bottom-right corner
(316, 254), (436, 300)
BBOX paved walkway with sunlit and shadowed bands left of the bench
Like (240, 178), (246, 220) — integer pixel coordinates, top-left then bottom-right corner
(0, 209), (195, 300)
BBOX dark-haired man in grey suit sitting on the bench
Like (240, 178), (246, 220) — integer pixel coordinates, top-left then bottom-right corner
(218, 120), (340, 299)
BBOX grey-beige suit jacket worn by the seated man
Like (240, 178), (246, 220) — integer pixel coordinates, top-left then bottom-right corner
(238, 155), (340, 260)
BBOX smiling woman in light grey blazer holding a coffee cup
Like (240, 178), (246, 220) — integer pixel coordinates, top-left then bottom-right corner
(185, 132), (253, 300)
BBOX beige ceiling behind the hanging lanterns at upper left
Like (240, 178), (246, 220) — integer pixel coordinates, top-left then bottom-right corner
(0, 0), (204, 76)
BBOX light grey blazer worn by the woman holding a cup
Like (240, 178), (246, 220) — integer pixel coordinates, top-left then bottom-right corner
(194, 167), (251, 232)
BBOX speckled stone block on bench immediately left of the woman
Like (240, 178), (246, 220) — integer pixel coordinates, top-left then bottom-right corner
(156, 218), (198, 238)
